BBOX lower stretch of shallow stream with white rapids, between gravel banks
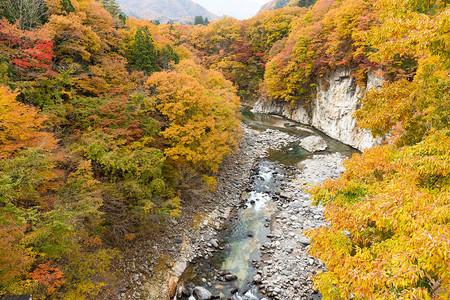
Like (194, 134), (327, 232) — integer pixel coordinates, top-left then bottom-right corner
(182, 161), (284, 297)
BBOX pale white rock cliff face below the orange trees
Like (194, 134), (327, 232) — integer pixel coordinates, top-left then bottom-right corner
(253, 70), (382, 150)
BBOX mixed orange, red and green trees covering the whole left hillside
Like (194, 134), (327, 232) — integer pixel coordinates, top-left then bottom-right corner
(0, 0), (239, 299)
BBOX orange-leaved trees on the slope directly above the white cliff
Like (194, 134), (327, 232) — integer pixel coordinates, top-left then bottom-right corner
(264, 0), (377, 102)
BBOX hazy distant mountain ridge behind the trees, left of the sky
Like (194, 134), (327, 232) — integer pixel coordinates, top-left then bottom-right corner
(117, 0), (218, 23)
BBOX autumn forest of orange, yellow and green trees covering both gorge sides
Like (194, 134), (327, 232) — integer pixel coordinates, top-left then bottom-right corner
(0, 0), (450, 299)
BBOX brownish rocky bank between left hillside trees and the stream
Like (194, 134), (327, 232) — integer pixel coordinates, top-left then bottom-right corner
(111, 124), (306, 299)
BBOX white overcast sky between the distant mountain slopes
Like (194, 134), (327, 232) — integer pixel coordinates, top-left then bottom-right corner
(193, 0), (270, 20)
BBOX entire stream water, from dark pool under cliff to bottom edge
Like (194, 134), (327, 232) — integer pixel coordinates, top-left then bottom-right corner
(175, 111), (356, 300)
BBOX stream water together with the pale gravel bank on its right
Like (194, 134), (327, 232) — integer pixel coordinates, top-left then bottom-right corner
(174, 110), (356, 300)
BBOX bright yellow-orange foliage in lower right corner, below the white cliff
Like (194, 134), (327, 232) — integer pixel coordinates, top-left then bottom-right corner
(308, 132), (450, 299)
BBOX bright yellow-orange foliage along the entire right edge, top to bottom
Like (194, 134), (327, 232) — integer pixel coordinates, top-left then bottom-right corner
(308, 0), (450, 299)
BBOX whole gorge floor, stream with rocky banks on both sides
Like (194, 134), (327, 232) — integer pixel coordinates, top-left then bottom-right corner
(144, 111), (356, 300)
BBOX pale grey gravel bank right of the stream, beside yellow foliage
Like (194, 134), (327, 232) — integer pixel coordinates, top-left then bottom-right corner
(254, 153), (345, 300)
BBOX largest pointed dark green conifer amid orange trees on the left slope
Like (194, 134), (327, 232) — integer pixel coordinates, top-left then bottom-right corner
(131, 27), (158, 74)
